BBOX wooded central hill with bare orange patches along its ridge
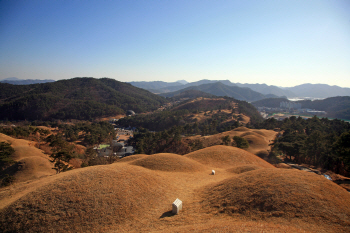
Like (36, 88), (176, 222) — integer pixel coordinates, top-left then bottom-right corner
(118, 97), (262, 135)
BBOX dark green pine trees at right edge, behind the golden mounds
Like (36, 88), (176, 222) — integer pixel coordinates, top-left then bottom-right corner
(255, 116), (350, 175)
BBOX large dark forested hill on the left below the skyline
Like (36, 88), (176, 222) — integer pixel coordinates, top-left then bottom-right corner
(0, 78), (166, 120)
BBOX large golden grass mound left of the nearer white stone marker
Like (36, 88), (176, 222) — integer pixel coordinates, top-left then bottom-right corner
(0, 164), (172, 232)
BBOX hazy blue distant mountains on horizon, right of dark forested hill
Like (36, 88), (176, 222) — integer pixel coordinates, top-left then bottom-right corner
(130, 79), (350, 98)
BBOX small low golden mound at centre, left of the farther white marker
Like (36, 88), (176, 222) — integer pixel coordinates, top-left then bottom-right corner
(131, 153), (205, 172)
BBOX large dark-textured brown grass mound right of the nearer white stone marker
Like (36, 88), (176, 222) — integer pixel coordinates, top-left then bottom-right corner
(203, 169), (350, 232)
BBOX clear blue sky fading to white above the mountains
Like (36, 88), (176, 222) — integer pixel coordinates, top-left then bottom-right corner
(0, 0), (350, 87)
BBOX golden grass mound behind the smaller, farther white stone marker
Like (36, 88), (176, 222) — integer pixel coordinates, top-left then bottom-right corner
(185, 145), (274, 168)
